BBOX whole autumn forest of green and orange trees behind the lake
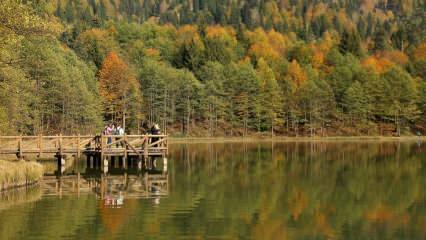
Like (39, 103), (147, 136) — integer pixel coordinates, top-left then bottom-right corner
(0, 0), (426, 136)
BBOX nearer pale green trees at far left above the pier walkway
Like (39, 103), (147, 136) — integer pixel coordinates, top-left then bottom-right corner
(0, 1), (100, 134)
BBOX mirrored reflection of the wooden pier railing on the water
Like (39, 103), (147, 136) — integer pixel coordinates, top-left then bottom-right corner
(41, 172), (169, 199)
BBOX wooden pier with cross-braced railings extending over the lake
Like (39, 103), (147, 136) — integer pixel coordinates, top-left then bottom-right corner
(0, 135), (168, 165)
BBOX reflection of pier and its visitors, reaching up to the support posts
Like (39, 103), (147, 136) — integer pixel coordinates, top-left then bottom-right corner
(41, 158), (169, 207)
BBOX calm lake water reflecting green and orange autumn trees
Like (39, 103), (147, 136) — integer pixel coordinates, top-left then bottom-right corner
(0, 142), (426, 239)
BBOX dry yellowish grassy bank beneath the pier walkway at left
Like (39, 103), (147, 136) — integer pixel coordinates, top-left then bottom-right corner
(0, 160), (43, 191)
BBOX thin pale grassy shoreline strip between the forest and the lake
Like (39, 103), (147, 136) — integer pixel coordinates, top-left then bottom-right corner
(169, 136), (426, 144)
